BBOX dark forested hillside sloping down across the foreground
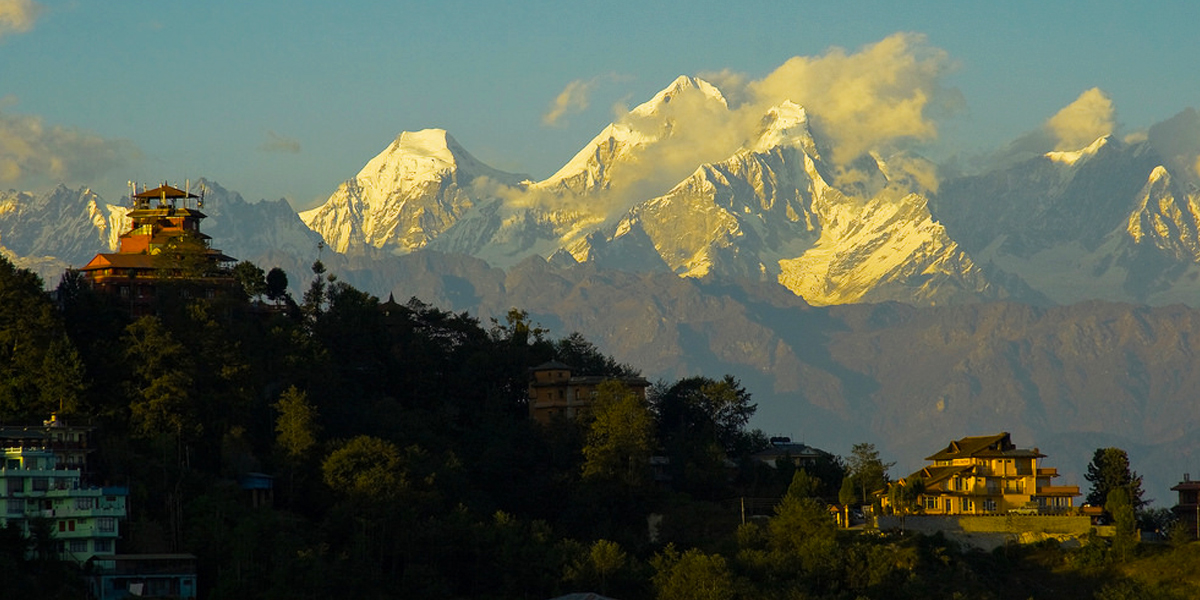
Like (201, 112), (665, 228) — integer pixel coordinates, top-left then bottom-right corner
(0, 259), (1200, 600)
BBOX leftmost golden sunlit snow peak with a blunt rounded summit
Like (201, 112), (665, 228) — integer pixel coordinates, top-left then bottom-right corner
(300, 130), (527, 253)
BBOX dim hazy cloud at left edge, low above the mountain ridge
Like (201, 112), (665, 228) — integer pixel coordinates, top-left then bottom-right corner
(0, 106), (139, 188)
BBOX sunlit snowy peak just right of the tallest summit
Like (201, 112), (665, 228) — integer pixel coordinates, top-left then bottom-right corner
(574, 97), (1000, 304)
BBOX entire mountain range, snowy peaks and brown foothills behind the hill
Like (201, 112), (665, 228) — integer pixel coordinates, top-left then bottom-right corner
(0, 77), (1200, 503)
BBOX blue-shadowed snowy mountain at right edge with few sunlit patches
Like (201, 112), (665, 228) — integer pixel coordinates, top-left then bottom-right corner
(934, 137), (1200, 304)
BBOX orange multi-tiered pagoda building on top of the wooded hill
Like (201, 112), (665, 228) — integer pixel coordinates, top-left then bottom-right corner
(79, 184), (236, 316)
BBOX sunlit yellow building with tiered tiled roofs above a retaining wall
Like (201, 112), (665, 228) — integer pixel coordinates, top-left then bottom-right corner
(884, 432), (1080, 515)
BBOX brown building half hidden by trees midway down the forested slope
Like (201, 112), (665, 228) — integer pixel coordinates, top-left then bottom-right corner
(529, 360), (650, 425)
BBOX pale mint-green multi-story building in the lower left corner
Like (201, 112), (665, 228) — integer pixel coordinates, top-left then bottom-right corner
(0, 440), (128, 563)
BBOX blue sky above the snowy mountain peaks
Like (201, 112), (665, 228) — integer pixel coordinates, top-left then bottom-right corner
(0, 0), (1200, 209)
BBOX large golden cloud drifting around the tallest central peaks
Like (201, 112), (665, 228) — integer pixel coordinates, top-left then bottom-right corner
(515, 34), (962, 216)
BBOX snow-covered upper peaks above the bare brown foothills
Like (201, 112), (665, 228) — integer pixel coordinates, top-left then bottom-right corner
(292, 77), (1200, 305)
